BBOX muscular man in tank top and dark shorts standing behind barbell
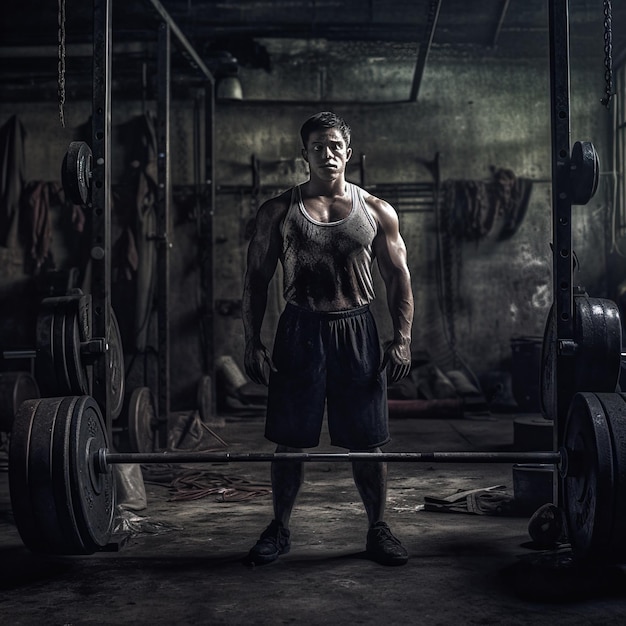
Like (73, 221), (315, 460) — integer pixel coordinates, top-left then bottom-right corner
(243, 112), (413, 565)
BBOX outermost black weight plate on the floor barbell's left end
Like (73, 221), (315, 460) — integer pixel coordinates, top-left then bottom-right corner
(9, 399), (46, 552)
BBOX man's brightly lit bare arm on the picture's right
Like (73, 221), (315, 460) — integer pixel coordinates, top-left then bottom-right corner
(368, 196), (414, 383)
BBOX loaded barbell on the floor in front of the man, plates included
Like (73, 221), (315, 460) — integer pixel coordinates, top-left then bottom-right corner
(9, 392), (626, 562)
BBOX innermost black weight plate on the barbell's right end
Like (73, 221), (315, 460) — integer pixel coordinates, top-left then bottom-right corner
(563, 392), (615, 561)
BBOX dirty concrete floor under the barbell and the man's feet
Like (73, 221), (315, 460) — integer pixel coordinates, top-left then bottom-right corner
(0, 404), (626, 625)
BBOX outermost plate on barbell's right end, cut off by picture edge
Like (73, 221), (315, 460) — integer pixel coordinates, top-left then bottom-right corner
(598, 393), (626, 563)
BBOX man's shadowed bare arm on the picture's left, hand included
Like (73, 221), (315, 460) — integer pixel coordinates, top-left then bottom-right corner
(242, 197), (286, 385)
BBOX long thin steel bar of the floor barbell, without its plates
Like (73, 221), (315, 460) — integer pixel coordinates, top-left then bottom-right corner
(95, 448), (562, 472)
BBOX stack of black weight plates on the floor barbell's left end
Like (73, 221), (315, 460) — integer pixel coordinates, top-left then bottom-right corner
(9, 396), (115, 555)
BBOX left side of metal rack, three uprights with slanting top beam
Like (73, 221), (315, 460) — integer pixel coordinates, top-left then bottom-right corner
(91, 0), (215, 432)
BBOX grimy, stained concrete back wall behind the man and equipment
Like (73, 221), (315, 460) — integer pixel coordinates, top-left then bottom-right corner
(0, 26), (610, 408)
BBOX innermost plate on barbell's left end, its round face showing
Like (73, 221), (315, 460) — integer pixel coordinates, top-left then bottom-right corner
(69, 396), (115, 553)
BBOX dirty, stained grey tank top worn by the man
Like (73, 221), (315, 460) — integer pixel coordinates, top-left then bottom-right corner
(281, 183), (377, 311)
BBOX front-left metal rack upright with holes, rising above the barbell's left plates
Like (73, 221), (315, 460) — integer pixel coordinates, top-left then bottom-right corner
(91, 0), (112, 433)
